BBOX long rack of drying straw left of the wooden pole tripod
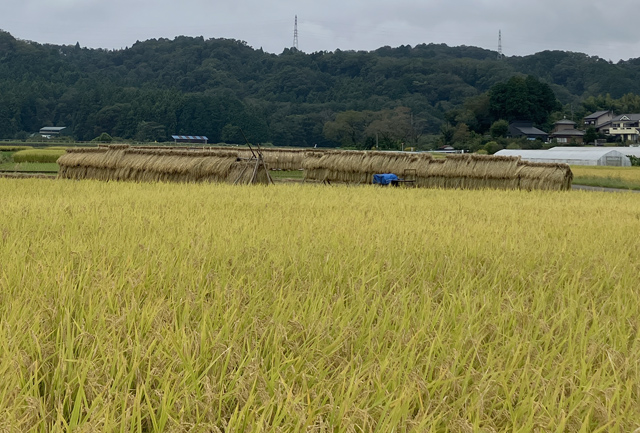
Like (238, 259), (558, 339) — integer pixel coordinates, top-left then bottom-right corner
(58, 145), (268, 183)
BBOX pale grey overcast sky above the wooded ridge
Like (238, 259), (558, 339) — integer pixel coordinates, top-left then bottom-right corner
(0, 0), (640, 62)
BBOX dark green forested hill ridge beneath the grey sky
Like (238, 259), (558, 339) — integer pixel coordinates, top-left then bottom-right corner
(0, 32), (640, 146)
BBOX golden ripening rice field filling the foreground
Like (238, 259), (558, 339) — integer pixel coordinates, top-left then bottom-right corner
(0, 179), (640, 433)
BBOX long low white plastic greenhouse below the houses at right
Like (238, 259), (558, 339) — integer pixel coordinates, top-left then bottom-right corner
(496, 147), (631, 167)
